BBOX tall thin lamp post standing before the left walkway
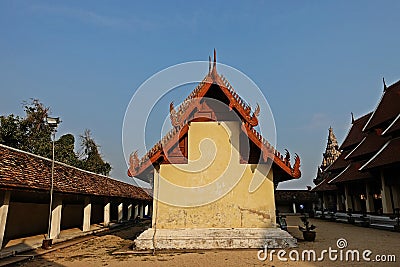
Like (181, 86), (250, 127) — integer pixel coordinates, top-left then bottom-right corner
(42, 117), (61, 249)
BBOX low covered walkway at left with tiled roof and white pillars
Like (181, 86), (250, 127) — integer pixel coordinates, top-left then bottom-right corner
(0, 145), (152, 251)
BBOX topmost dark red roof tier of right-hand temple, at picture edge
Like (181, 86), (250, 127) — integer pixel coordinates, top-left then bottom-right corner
(363, 81), (400, 131)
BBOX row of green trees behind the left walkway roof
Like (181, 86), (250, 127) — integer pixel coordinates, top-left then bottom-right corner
(0, 99), (111, 175)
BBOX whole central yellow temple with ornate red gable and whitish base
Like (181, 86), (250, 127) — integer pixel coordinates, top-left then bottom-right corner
(128, 51), (301, 249)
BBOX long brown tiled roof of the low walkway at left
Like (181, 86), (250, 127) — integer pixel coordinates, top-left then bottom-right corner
(0, 145), (151, 200)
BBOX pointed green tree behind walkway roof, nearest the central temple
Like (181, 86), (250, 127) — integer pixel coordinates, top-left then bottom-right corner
(80, 129), (112, 175)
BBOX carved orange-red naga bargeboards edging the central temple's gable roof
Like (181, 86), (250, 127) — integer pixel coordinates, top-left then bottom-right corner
(128, 50), (301, 180)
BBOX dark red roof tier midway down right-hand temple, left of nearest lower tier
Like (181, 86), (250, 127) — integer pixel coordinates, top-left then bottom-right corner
(345, 129), (389, 160)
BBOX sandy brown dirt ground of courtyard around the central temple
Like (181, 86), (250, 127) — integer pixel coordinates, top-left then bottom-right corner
(18, 216), (400, 267)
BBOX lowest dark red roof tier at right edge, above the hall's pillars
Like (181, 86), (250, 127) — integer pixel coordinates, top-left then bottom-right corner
(360, 137), (400, 170)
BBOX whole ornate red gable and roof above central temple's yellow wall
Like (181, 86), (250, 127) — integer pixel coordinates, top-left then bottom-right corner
(128, 50), (301, 181)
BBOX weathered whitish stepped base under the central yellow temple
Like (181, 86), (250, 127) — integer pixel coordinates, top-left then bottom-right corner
(134, 228), (297, 250)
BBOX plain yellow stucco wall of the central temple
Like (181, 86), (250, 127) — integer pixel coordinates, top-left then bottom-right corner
(153, 122), (275, 229)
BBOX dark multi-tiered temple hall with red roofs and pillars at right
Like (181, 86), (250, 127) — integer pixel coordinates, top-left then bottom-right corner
(313, 81), (400, 215)
